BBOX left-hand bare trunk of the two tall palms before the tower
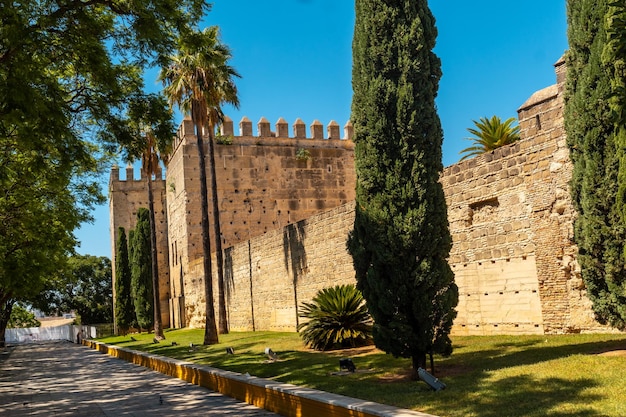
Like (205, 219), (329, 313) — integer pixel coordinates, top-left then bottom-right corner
(191, 105), (219, 345)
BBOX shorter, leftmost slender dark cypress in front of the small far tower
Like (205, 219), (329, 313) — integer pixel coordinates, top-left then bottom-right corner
(115, 227), (135, 334)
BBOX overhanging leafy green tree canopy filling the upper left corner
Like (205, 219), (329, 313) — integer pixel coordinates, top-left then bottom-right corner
(0, 0), (209, 343)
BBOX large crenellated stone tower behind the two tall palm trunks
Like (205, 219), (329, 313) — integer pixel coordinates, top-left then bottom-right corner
(166, 117), (355, 327)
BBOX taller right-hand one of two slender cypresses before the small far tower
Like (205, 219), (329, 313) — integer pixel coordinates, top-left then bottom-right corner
(131, 208), (154, 329)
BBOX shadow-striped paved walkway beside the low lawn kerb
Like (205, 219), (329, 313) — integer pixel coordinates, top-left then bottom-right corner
(0, 342), (278, 417)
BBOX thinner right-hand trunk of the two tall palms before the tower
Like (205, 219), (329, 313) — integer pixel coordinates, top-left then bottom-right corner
(209, 126), (228, 334)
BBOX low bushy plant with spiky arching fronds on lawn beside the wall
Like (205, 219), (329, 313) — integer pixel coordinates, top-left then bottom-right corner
(298, 285), (372, 350)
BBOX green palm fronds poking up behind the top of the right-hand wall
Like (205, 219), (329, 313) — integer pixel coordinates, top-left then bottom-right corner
(459, 116), (520, 161)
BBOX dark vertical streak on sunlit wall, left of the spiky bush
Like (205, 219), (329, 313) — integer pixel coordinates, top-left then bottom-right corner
(283, 221), (307, 325)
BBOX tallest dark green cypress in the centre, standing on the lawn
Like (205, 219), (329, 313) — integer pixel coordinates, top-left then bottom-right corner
(348, 0), (458, 371)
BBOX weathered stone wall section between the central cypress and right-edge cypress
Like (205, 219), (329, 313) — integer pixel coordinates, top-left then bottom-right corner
(442, 60), (599, 334)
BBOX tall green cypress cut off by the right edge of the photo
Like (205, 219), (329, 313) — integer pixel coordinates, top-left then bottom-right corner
(565, 0), (626, 329)
